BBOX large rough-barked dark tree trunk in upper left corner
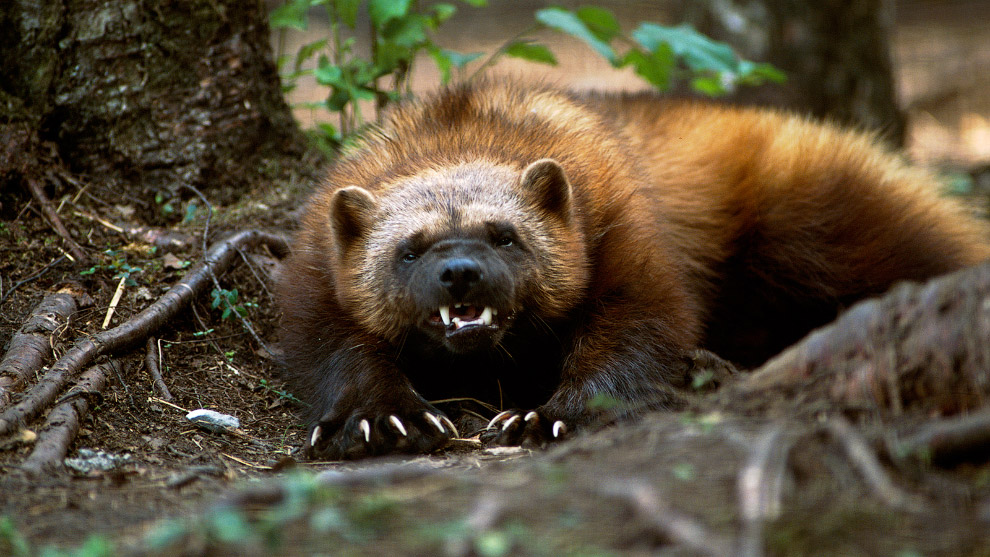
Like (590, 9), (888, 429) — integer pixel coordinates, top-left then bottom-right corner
(0, 0), (303, 216)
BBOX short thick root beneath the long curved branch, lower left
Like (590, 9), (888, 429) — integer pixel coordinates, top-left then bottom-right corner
(21, 360), (117, 476)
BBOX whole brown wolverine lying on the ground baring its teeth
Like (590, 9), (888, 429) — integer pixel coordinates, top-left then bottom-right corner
(278, 81), (990, 459)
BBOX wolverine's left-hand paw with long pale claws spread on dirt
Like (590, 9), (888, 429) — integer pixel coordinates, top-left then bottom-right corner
(304, 404), (458, 460)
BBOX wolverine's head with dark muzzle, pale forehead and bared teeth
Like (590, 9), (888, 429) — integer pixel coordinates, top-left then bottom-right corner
(330, 159), (587, 353)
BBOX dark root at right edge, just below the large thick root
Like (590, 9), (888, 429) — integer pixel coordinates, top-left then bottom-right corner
(888, 411), (990, 460)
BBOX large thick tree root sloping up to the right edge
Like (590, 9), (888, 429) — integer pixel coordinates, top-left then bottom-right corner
(723, 264), (990, 417)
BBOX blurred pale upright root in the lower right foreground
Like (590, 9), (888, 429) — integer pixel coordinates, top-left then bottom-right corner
(736, 424), (790, 557)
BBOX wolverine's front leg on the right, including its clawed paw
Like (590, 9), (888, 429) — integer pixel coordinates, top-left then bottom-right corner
(488, 304), (691, 446)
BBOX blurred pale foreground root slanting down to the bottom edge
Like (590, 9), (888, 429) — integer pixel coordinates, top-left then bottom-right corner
(599, 480), (733, 557)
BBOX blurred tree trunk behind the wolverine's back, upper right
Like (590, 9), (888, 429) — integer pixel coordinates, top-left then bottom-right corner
(680, 0), (904, 145)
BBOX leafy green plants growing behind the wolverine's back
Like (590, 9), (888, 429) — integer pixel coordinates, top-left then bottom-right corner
(272, 0), (784, 152)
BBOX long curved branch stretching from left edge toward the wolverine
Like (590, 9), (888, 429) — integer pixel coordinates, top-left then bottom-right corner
(0, 230), (288, 435)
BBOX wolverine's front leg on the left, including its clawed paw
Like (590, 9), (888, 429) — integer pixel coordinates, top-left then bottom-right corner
(304, 345), (458, 460)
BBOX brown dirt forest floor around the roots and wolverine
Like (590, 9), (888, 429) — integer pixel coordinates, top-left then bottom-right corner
(0, 1), (990, 557)
